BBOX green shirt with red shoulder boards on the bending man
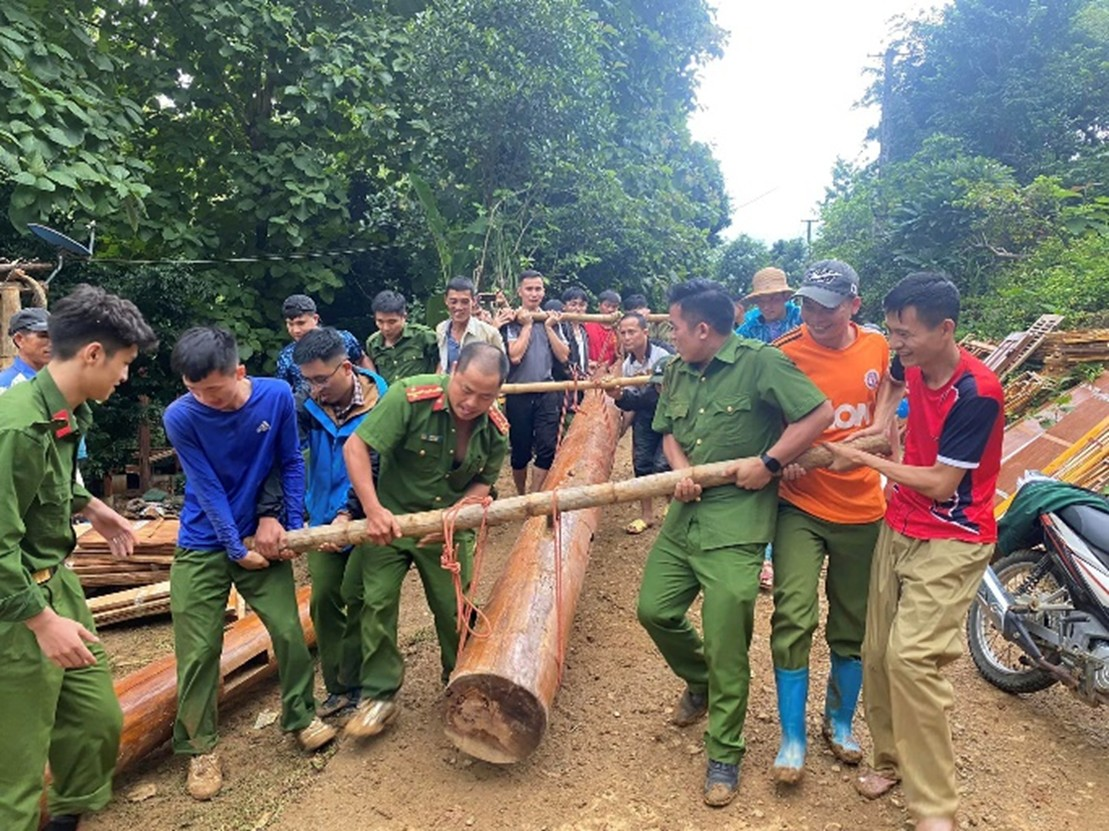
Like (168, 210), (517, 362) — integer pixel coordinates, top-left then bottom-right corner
(355, 375), (508, 514)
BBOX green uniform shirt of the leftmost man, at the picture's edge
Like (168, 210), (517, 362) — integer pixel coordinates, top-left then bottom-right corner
(0, 367), (92, 621)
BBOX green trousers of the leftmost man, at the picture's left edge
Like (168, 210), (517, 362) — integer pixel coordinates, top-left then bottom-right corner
(0, 567), (123, 831)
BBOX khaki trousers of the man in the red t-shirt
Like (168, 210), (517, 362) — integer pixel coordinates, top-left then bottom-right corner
(863, 523), (994, 818)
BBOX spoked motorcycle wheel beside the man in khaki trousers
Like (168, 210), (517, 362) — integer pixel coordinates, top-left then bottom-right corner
(967, 550), (1059, 693)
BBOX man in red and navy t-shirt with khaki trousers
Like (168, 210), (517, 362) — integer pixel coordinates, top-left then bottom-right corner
(827, 272), (1005, 831)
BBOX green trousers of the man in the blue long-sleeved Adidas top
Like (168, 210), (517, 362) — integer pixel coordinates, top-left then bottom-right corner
(170, 548), (316, 756)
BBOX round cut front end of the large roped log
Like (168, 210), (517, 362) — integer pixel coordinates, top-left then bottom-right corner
(444, 673), (547, 764)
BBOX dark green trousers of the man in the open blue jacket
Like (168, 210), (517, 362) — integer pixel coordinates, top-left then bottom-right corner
(308, 549), (362, 695)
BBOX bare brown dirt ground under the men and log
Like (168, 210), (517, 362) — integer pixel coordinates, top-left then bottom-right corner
(82, 439), (1109, 831)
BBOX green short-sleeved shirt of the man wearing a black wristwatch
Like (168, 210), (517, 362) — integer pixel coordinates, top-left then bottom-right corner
(651, 334), (825, 549)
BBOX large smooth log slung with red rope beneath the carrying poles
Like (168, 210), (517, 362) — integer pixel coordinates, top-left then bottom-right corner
(446, 396), (620, 764)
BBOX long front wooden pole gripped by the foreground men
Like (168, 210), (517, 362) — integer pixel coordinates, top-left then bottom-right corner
(268, 430), (889, 554)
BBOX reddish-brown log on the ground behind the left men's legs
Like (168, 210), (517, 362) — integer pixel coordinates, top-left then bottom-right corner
(115, 587), (316, 773)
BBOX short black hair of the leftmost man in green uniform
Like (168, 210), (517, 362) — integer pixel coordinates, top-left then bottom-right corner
(48, 283), (157, 361)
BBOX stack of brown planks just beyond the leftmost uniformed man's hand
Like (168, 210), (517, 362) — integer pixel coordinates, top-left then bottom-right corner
(69, 519), (179, 588)
